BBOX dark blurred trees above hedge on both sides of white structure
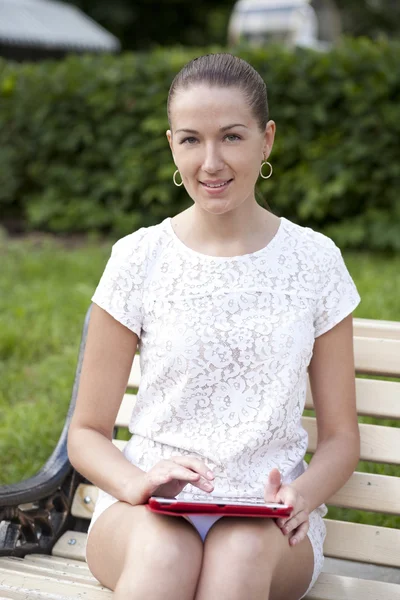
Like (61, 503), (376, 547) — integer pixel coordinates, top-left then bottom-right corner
(65, 0), (400, 50)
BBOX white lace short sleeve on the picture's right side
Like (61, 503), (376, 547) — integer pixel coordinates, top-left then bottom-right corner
(314, 244), (361, 337)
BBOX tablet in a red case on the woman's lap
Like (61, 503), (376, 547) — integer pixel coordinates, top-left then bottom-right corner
(146, 496), (293, 519)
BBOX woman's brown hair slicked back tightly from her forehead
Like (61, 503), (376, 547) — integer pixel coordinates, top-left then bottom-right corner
(167, 53), (268, 131)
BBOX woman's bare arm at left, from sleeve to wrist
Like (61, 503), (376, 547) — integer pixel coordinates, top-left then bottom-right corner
(67, 304), (148, 504)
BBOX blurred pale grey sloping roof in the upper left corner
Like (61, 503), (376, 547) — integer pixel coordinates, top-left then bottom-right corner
(0, 0), (121, 61)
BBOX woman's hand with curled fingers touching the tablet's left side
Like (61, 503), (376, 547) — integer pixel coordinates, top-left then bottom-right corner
(144, 456), (214, 502)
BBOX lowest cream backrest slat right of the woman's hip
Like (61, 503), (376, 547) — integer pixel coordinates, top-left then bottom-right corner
(324, 519), (400, 567)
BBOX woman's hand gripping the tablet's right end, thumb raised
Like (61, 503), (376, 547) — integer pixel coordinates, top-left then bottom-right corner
(264, 469), (309, 546)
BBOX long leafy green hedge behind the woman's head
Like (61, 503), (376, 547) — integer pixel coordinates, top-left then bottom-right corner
(0, 38), (400, 250)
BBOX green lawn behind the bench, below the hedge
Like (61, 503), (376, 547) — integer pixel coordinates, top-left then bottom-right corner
(0, 235), (400, 525)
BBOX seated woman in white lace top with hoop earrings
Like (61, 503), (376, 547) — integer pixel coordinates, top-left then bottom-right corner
(69, 54), (360, 600)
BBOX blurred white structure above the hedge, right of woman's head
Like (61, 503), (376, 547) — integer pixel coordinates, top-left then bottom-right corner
(228, 0), (342, 50)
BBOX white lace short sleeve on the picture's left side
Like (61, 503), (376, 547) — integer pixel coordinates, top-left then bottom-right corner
(91, 227), (147, 337)
